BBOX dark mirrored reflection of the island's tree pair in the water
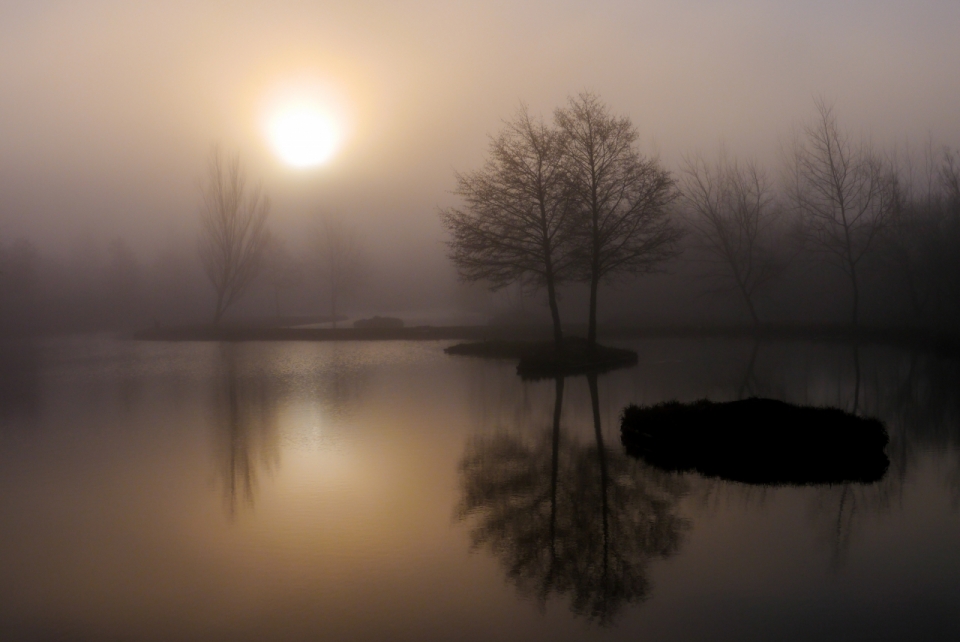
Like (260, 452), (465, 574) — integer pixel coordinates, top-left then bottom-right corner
(457, 375), (690, 624)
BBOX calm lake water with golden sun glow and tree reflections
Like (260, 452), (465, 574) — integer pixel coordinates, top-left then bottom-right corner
(0, 337), (960, 641)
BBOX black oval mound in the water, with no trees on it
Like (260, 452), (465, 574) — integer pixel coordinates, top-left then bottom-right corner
(620, 398), (890, 485)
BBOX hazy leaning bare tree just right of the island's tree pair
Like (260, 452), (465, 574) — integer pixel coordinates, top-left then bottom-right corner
(681, 152), (784, 327)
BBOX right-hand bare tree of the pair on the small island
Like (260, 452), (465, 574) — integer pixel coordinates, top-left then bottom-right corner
(556, 93), (682, 345)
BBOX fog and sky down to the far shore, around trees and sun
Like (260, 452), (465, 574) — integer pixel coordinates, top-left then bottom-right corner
(0, 0), (960, 330)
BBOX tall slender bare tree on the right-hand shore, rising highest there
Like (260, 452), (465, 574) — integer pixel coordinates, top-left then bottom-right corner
(789, 100), (894, 328)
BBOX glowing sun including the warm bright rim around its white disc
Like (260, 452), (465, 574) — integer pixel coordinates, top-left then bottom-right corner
(264, 82), (345, 168)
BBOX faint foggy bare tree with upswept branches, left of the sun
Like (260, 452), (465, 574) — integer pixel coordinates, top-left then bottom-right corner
(198, 147), (270, 325)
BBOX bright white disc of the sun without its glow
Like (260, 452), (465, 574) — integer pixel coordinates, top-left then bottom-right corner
(267, 106), (339, 167)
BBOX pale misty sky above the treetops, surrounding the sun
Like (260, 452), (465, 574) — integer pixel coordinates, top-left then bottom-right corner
(0, 0), (960, 261)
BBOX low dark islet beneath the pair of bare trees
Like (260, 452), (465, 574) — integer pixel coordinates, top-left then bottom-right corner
(444, 337), (637, 379)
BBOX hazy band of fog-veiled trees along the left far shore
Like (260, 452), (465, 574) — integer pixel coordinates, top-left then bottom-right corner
(0, 147), (364, 334)
